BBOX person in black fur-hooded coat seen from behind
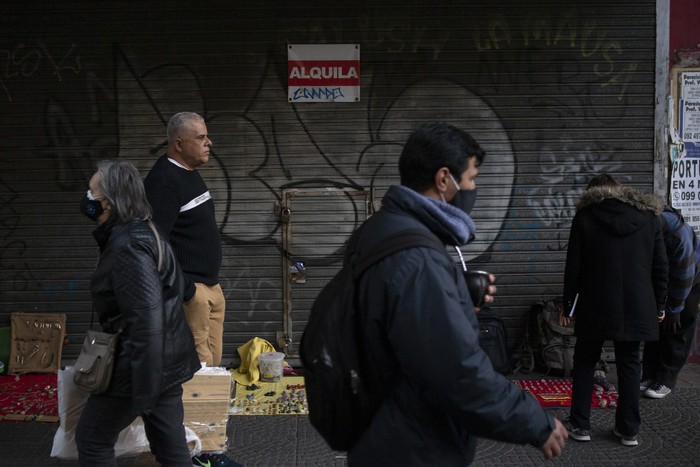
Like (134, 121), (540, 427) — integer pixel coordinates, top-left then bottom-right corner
(564, 174), (668, 446)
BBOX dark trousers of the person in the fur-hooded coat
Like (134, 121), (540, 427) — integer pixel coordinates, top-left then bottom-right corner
(570, 337), (642, 436)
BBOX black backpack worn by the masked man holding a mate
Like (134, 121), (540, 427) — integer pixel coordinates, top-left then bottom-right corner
(299, 229), (442, 451)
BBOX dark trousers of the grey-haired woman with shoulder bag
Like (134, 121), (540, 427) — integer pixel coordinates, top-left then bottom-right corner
(75, 385), (192, 467)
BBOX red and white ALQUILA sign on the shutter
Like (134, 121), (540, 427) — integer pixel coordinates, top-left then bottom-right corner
(287, 44), (360, 103)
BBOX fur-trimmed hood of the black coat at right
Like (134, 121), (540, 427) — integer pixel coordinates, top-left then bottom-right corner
(576, 186), (664, 236)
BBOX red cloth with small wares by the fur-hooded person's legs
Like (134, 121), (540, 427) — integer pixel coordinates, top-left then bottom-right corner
(513, 378), (617, 407)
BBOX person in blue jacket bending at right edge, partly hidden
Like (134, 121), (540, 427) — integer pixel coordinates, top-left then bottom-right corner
(639, 206), (700, 399)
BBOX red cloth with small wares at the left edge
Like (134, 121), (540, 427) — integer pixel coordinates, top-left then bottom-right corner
(0, 373), (58, 422)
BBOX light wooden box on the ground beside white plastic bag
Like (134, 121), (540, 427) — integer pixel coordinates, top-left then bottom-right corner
(182, 368), (232, 451)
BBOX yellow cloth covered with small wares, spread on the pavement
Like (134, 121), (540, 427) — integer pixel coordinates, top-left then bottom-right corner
(229, 376), (309, 415)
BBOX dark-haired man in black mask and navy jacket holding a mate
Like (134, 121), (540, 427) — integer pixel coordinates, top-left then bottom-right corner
(348, 123), (567, 466)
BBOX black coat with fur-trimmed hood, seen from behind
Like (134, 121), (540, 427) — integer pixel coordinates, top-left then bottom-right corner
(564, 186), (668, 341)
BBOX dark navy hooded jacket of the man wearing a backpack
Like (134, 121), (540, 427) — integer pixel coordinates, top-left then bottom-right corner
(348, 187), (553, 466)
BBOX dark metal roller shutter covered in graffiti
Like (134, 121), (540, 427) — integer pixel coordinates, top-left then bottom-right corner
(0, 0), (656, 366)
